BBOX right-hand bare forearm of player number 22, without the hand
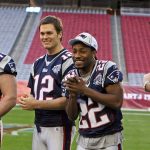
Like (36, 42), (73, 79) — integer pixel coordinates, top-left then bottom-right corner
(83, 88), (123, 109)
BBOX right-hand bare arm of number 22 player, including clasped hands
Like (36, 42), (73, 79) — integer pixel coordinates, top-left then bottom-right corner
(65, 77), (123, 109)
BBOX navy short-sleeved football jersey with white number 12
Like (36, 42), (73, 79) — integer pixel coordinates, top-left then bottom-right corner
(28, 49), (74, 127)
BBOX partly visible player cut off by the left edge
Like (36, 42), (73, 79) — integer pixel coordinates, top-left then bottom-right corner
(0, 53), (17, 145)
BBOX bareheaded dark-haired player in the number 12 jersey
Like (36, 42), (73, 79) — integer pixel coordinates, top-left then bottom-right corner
(20, 16), (75, 150)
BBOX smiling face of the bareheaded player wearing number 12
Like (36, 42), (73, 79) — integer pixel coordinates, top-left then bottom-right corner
(40, 24), (62, 53)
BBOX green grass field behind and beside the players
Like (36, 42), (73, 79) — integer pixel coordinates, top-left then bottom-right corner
(2, 108), (150, 150)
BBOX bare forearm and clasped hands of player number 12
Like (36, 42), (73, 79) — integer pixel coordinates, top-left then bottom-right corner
(19, 95), (66, 110)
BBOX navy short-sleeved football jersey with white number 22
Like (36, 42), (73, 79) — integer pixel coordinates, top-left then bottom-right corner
(63, 60), (123, 137)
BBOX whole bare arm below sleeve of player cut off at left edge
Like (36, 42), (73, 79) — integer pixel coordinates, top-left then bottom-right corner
(0, 74), (17, 117)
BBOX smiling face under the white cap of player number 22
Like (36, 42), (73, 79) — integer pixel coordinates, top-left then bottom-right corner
(72, 43), (96, 72)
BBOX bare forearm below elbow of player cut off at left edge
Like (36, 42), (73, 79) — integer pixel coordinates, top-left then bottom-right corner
(0, 97), (16, 117)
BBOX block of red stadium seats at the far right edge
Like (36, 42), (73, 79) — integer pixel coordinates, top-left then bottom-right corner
(121, 16), (150, 73)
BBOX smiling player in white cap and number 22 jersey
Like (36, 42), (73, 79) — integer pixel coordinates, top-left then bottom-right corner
(63, 32), (123, 150)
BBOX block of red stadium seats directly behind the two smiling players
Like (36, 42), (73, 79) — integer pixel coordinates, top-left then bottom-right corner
(24, 12), (112, 64)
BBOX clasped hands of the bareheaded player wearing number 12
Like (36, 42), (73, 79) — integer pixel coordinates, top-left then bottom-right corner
(19, 95), (37, 110)
